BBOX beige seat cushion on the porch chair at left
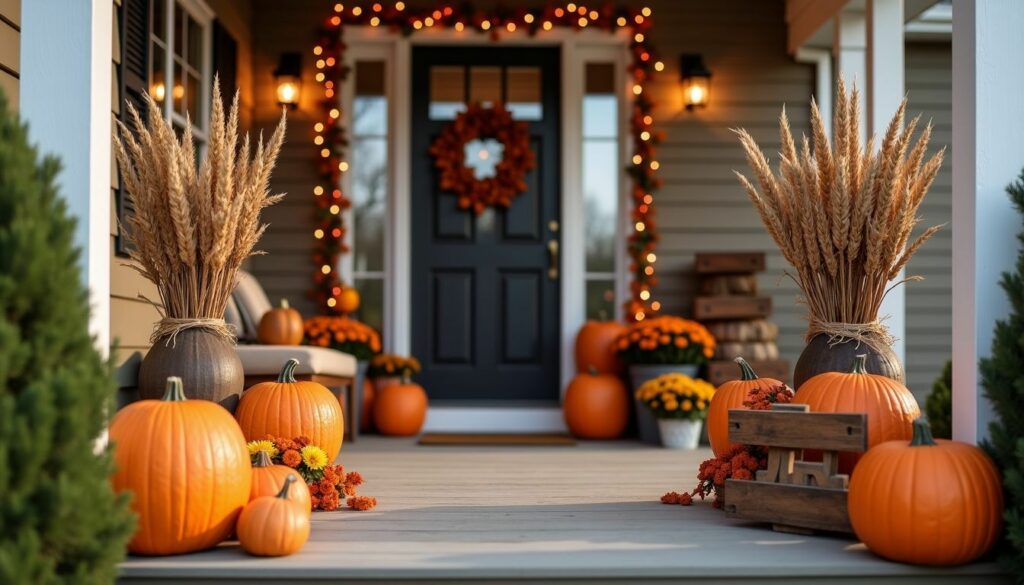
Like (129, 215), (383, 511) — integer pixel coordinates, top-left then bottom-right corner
(236, 345), (356, 378)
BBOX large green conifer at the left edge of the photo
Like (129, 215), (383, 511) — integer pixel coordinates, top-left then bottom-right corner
(0, 95), (134, 585)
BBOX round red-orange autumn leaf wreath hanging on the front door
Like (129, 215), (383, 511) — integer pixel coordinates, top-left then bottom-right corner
(430, 103), (536, 214)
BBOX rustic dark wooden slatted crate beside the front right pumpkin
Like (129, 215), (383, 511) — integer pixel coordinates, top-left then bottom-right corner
(723, 405), (867, 534)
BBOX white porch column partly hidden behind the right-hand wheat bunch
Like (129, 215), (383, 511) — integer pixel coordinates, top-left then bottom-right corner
(864, 0), (907, 367)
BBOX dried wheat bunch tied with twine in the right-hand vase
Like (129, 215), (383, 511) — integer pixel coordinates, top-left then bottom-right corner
(736, 80), (945, 342)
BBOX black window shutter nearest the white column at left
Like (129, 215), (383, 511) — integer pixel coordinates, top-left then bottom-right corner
(115, 0), (152, 256)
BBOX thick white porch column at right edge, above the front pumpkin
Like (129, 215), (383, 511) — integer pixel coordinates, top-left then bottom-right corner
(952, 0), (1024, 443)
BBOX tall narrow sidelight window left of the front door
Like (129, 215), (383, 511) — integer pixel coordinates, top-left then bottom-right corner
(348, 60), (390, 331)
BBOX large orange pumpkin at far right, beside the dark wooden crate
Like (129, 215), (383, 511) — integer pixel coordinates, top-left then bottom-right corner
(848, 419), (1002, 565)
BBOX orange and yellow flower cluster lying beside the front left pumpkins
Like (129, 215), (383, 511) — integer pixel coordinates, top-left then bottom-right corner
(260, 435), (377, 512)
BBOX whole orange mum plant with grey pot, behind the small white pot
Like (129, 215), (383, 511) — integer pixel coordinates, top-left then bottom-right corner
(615, 316), (715, 444)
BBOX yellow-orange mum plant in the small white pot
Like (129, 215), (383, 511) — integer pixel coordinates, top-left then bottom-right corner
(636, 374), (715, 451)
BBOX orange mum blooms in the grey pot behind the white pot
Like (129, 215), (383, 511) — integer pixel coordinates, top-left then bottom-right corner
(615, 316), (715, 364)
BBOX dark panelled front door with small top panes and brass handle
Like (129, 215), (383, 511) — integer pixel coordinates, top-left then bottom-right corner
(412, 46), (561, 406)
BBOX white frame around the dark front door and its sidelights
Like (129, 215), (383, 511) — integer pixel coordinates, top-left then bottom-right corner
(340, 26), (632, 432)
